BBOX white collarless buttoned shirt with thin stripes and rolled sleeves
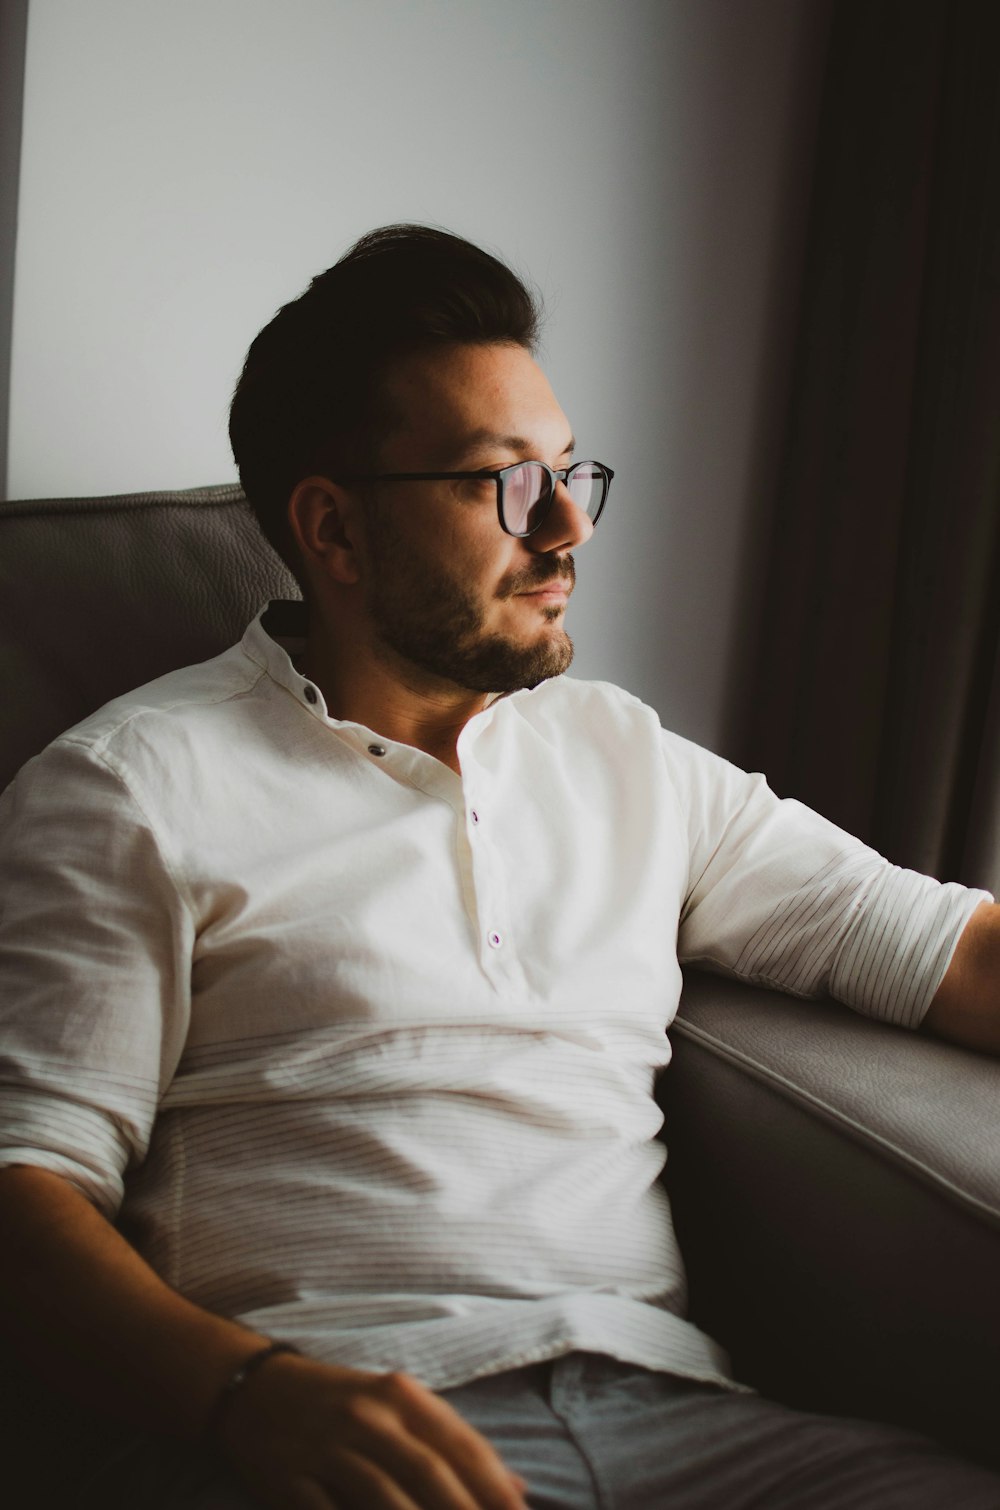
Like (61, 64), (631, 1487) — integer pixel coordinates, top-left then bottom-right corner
(0, 600), (985, 1388)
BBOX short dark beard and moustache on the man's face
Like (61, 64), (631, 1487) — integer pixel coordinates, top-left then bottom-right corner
(369, 530), (576, 693)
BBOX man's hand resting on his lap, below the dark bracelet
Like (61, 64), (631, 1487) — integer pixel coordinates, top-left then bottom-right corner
(216, 1354), (526, 1510)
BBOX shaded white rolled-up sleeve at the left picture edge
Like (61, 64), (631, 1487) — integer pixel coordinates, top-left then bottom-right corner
(0, 737), (193, 1217)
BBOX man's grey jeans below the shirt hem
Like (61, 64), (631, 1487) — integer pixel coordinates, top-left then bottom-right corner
(87, 1353), (1000, 1510)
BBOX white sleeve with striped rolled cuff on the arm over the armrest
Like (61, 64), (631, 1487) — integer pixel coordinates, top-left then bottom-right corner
(665, 735), (992, 1027)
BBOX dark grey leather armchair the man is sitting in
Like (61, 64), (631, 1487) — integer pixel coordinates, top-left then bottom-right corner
(0, 486), (1000, 1485)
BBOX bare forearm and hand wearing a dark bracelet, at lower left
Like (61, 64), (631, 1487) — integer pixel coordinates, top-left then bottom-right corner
(0, 1166), (524, 1510)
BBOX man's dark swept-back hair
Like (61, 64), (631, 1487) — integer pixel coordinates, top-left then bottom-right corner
(230, 225), (539, 574)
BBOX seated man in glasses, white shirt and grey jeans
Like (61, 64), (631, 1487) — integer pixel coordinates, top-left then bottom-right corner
(0, 227), (1000, 1510)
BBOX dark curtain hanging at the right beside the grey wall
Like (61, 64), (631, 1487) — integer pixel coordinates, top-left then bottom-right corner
(740, 0), (1000, 891)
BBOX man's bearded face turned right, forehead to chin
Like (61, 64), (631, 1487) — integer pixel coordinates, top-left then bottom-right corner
(358, 346), (594, 692)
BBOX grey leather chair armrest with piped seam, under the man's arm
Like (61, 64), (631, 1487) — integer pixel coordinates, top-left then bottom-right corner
(660, 971), (1000, 1463)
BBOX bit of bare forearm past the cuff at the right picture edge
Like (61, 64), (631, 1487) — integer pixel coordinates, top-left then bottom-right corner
(923, 901), (1000, 1054)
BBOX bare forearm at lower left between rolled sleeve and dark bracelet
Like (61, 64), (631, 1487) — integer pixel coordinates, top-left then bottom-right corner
(0, 1167), (267, 1439)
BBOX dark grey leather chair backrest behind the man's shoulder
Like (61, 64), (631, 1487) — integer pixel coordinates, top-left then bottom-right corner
(0, 486), (299, 790)
